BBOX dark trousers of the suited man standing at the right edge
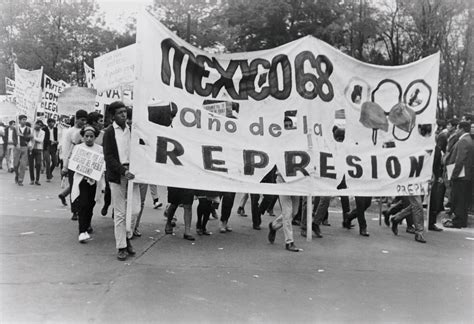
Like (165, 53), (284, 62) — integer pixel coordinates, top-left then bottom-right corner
(452, 179), (472, 227)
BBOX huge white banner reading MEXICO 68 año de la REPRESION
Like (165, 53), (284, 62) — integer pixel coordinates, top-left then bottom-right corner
(130, 13), (439, 196)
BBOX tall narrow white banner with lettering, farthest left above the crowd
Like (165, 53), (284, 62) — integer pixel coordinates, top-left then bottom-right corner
(14, 64), (43, 122)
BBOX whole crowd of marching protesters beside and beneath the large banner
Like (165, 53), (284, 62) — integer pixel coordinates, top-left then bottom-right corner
(0, 101), (474, 261)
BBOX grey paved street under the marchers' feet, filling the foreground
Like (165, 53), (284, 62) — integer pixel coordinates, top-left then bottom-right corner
(0, 170), (474, 323)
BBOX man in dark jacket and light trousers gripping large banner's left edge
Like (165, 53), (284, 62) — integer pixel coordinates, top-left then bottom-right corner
(103, 101), (140, 261)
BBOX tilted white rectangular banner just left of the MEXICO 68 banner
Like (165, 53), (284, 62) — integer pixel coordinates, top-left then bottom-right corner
(94, 44), (136, 92)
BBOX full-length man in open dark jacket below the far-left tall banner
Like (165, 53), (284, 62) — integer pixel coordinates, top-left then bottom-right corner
(13, 115), (32, 186)
